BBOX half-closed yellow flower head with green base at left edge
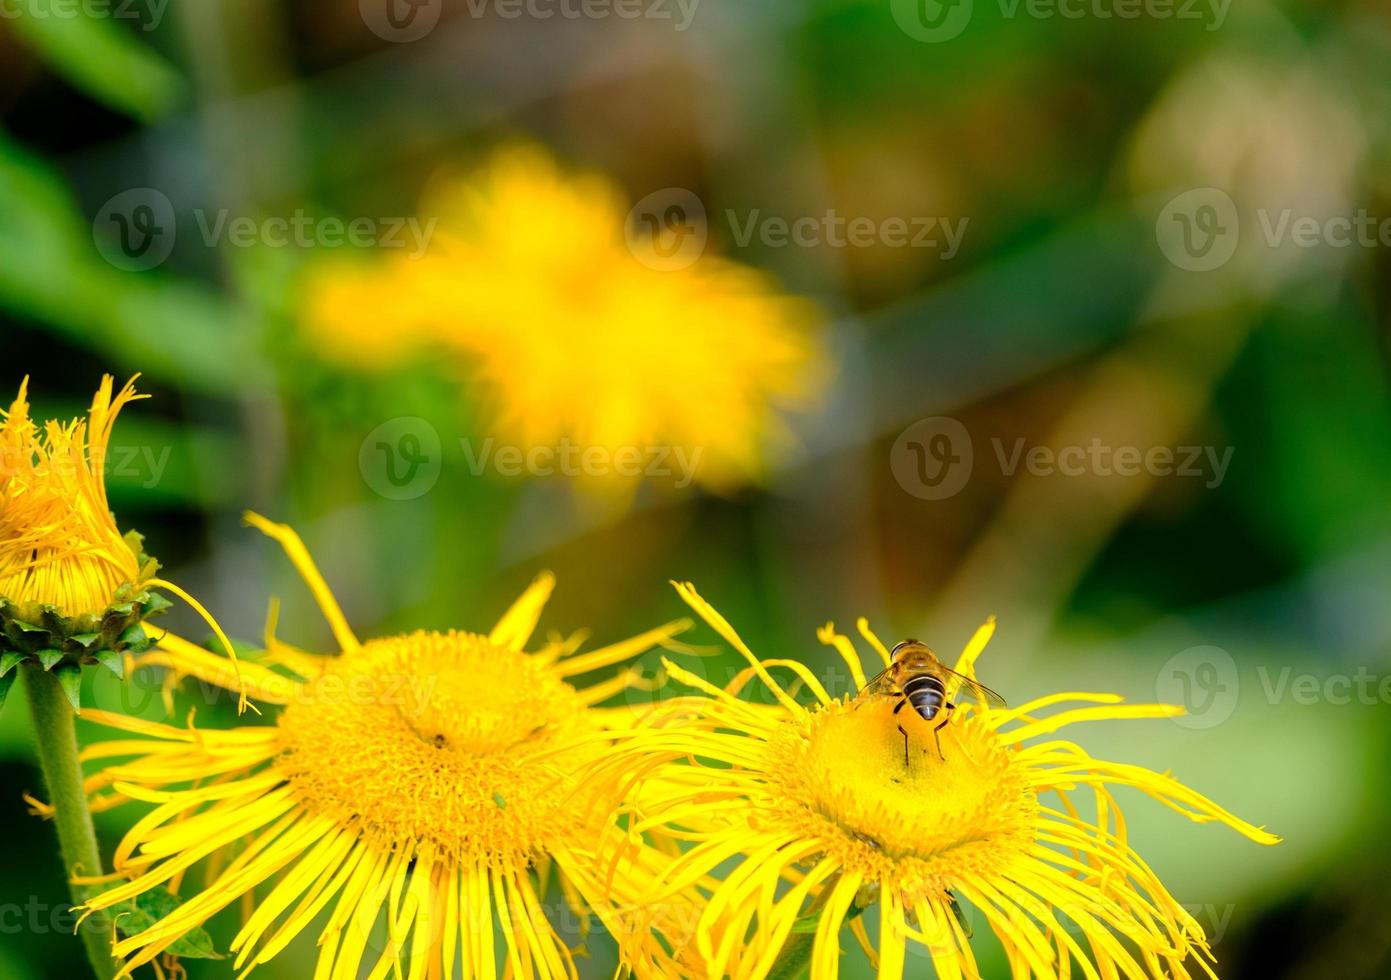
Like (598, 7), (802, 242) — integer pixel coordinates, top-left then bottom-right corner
(0, 375), (235, 708)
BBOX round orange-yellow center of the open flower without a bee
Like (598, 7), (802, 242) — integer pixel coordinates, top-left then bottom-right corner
(275, 632), (605, 867)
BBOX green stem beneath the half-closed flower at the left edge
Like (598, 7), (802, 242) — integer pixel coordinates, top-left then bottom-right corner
(25, 667), (115, 980)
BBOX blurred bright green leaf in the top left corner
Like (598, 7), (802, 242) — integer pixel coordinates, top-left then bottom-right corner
(3, 0), (185, 121)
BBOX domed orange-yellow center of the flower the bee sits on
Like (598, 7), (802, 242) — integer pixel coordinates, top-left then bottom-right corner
(769, 698), (1038, 891)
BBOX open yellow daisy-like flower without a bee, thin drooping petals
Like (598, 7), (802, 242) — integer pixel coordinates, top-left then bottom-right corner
(73, 516), (689, 980)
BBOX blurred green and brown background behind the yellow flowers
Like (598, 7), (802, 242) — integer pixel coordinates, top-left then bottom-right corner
(0, 0), (1391, 980)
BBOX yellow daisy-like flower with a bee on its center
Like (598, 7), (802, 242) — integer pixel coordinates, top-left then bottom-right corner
(629, 584), (1278, 980)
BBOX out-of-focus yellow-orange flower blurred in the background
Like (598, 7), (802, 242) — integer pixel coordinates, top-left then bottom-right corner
(306, 147), (829, 491)
